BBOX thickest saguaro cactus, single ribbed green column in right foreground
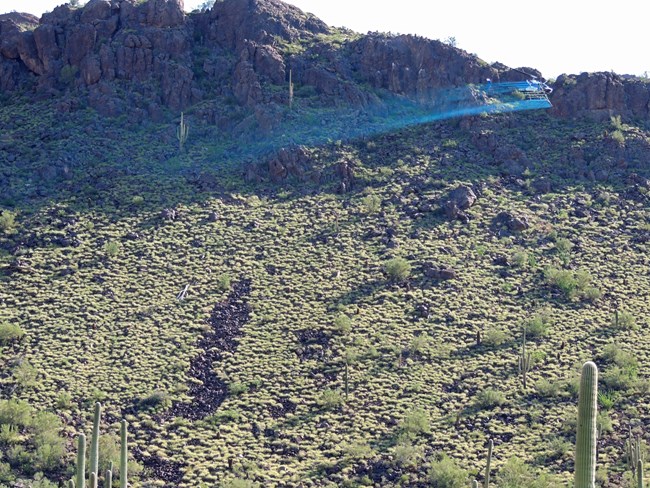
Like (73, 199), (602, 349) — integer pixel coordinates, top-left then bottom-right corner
(574, 361), (598, 488)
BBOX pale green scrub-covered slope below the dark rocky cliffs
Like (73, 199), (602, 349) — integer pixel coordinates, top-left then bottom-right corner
(0, 89), (650, 487)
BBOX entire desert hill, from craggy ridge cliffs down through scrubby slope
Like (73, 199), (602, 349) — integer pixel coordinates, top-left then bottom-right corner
(0, 0), (650, 488)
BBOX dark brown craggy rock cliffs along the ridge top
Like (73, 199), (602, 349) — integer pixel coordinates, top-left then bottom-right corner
(0, 0), (650, 126)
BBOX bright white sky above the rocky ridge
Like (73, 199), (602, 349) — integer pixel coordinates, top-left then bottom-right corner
(0, 0), (650, 78)
